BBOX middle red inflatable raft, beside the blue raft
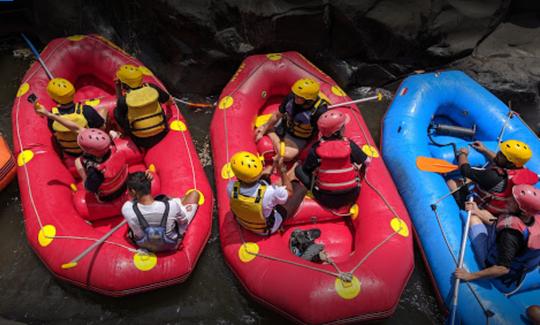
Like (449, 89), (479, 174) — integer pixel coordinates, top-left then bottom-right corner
(211, 52), (414, 324)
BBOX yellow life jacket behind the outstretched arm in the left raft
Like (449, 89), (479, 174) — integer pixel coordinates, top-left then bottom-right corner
(52, 103), (88, 155)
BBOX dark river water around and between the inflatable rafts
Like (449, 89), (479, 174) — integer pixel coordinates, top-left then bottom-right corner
(0, 44), (442, 324)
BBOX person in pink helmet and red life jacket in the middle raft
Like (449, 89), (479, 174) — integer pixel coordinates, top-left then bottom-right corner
(295, 110), (370, 209)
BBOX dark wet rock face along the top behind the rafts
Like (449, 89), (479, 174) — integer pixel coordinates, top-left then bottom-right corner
(26, 0), (540, 132)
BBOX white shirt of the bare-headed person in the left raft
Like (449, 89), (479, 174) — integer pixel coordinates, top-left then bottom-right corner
(122, 198), (198, 239)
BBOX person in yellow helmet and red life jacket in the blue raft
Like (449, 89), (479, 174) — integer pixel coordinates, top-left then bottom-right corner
(447, 140), (538, 215)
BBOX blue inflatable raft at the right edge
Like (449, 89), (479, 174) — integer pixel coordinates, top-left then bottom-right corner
(382, 71), (540, 325)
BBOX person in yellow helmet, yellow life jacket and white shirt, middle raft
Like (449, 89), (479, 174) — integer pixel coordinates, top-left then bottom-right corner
(227, 151), (307, 236)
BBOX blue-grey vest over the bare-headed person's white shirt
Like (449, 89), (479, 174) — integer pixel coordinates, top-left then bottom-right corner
(133, 195), (180, 252)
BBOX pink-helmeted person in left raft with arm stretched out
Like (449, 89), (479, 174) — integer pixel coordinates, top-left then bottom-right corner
(36, 105), (128, 202)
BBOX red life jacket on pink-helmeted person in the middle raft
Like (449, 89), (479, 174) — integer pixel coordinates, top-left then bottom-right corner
(315, 138), (360, 191)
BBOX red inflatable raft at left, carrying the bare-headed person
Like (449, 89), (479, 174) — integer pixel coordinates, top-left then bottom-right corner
(13, 35), (213, 296)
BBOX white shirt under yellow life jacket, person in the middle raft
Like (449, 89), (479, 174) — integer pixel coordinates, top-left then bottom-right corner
(227, 180), (289, 233)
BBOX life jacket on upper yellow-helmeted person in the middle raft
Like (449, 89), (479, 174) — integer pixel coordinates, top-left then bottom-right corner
(284, 98), (327, 139)
